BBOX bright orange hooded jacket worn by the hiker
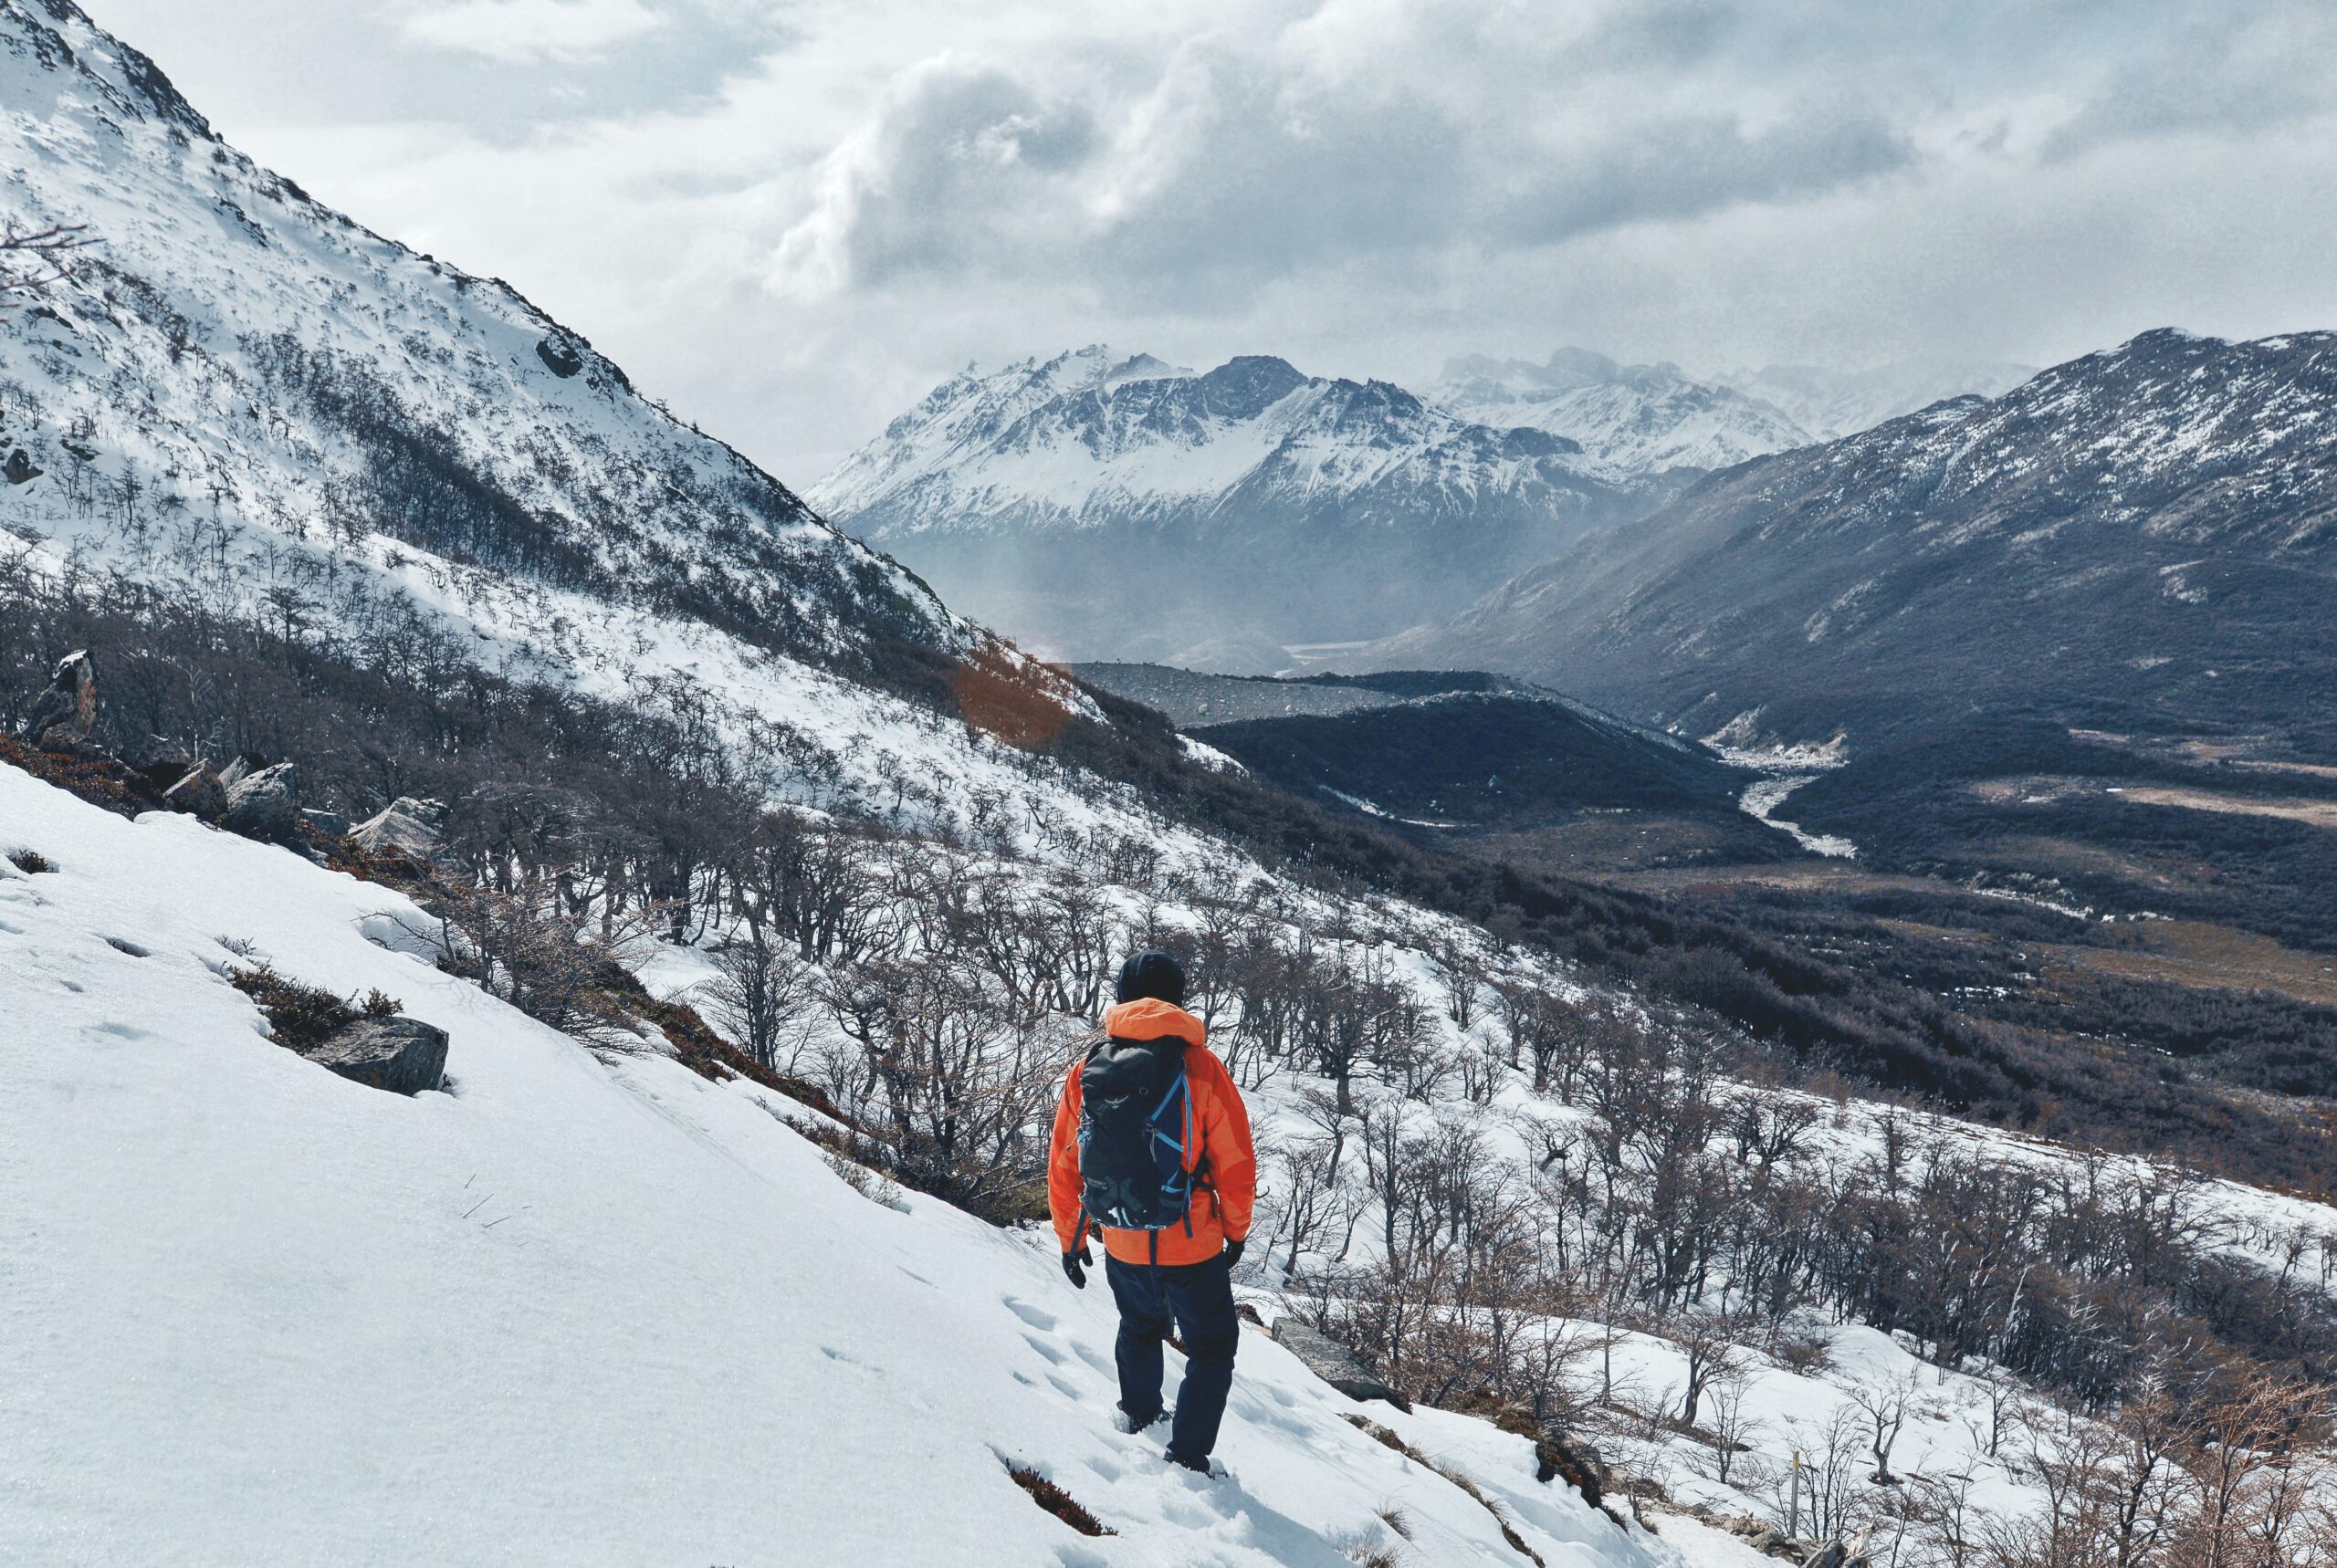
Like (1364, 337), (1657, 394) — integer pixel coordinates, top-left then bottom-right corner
(1047, 998), (1257, 1264)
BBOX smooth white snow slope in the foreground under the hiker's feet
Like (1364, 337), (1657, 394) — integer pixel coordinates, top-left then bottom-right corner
(0, 767), (1678, 1568)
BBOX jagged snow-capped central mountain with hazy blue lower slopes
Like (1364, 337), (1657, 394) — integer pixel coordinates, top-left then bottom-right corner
(809, 346), (1643, 662)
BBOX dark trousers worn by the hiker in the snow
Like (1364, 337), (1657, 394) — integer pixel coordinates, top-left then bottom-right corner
(1103, 1257), (1241, 1460)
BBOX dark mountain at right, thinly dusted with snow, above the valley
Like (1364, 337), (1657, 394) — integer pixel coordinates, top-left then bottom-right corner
(1374, 329), (2337, 738)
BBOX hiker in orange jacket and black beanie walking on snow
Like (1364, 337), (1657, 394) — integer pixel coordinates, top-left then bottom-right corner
(1047, 954), (1257, 1475)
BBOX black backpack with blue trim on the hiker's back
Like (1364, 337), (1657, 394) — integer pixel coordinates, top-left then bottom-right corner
(1080, 1040), (1199, 1234)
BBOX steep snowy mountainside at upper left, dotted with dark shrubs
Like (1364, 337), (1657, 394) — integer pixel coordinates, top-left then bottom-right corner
(0, 0), (968, 654)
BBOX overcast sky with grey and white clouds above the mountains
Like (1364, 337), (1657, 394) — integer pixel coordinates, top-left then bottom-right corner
(84, 0), (2337, 486)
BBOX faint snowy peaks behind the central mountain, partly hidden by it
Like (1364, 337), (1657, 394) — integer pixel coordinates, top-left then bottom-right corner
(1428, 348), (1818, 475)
